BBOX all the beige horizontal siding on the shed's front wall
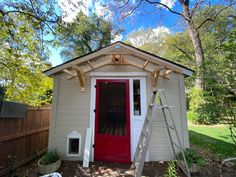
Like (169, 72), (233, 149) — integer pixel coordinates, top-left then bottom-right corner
(49, 65), (189, 161)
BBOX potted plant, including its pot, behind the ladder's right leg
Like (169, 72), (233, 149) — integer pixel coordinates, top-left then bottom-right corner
(178, 148), (206, 173)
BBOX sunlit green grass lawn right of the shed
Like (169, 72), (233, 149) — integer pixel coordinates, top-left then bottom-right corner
(188, 122), (236, 158)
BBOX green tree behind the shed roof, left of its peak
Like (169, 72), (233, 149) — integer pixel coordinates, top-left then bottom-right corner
(57, 11), (120, 60)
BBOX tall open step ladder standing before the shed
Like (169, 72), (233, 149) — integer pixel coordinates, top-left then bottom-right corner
(131, 89), (191, 177)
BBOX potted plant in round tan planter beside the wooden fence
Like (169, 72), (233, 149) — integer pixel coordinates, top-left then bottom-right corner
(38, 150), (61, 174)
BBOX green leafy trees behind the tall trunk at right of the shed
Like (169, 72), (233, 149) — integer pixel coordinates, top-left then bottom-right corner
(124, 6), (236, 125)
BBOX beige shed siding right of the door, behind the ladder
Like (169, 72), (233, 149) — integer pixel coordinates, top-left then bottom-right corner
(147, 73), (188, 161)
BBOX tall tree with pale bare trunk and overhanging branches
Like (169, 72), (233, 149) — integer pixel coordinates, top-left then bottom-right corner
(108, 0), (235, 90)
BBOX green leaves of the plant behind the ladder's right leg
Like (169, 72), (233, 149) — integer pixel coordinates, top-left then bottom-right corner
(178, 148), (206, 168)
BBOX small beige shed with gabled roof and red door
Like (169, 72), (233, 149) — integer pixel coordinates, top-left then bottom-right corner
(45, 42), (193, 163)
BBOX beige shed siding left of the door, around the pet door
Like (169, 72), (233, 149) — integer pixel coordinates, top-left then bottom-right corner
(50, 73), (90, 160)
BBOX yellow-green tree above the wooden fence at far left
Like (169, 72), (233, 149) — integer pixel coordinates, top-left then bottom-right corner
(0, 0), (59, 105)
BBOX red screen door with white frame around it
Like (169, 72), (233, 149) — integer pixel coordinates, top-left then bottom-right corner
(94, 80), (131, 163)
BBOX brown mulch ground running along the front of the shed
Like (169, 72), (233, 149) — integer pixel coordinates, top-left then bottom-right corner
(9, 146), (236, 177)
